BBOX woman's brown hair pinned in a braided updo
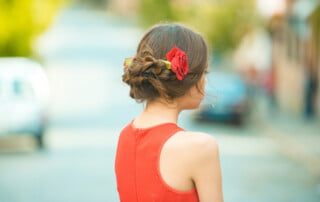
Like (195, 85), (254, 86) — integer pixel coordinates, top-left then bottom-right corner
(122, 24), (208, 102)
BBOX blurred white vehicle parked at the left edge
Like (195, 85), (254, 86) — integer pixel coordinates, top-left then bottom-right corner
(0, 57), (49, 148)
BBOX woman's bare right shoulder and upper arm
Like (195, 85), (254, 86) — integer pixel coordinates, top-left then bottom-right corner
(166, 132), (223, 202)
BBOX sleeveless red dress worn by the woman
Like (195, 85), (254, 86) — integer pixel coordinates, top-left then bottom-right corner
(115, 122), (199, 202)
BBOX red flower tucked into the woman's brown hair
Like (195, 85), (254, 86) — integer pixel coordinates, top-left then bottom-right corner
(166, 46), (189, 81)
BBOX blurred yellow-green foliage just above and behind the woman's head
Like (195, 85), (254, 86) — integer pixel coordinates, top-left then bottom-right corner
(140, 0), (259, 54)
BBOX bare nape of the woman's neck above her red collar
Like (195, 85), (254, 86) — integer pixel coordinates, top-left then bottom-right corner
(135, 101), (181, 127)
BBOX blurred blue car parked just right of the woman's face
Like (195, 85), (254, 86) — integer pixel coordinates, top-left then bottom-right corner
(195, 72), (249, 124)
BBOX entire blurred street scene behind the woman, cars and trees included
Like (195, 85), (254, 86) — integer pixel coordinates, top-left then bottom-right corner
(0, 0), (320, 202)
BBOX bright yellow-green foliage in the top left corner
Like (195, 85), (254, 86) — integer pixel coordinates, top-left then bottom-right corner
(0, 0), (65, 56)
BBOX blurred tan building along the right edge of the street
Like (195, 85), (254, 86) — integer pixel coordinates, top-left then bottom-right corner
(269, 0), (320, 117)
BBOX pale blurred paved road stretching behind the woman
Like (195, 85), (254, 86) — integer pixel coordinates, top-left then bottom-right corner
(0, 3), (320, 202)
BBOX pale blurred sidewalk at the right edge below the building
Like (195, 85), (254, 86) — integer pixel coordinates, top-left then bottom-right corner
(261, 111), (320, 180)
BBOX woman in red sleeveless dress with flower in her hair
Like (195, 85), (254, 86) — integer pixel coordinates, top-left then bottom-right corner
(115, 24), (223, 202)
